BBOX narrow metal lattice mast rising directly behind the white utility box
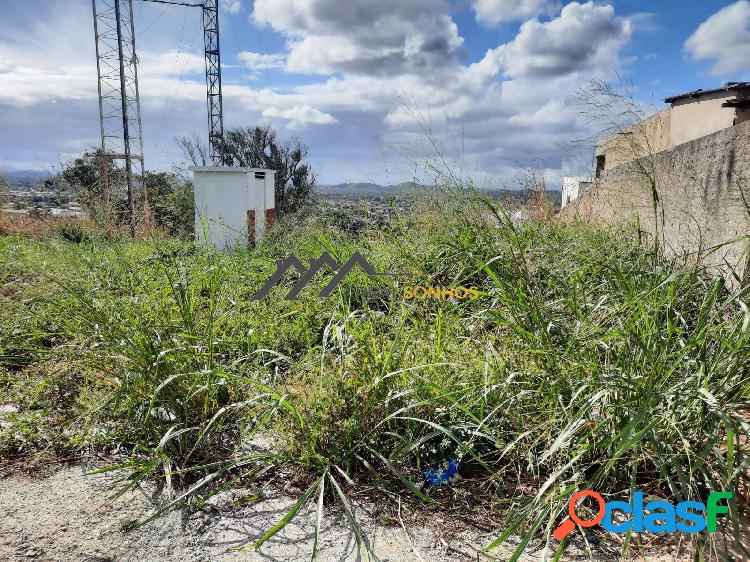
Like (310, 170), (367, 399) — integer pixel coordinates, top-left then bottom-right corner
(203, 0), (226, 166)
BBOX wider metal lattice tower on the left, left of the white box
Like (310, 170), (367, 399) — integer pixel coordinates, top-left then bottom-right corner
(92, 0), (148, 235)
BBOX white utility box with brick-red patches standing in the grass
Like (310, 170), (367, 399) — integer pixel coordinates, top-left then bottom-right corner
(190, 166), (276, 250)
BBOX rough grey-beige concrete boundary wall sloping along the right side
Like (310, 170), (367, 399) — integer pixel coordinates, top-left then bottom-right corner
(561, 122), (750, 277)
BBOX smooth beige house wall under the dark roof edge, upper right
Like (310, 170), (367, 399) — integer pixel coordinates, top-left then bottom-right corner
(670, 92), (736, 146)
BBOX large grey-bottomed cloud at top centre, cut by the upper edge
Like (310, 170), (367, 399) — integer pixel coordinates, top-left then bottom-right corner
(253, 0), (463, 75)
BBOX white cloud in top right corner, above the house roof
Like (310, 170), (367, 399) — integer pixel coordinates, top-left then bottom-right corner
(685, 0), (750, 75)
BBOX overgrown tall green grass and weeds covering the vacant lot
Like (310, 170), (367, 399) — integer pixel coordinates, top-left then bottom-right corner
(0, 190), (750, 558)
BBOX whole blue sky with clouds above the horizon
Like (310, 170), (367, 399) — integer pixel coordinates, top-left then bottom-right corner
(0, 0), (750, 184)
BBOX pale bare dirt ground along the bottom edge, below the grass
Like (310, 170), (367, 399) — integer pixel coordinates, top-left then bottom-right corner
(0, 460), (532, 562)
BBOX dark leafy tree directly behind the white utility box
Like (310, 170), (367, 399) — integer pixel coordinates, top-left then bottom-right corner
(177, 125), (315, 215)
